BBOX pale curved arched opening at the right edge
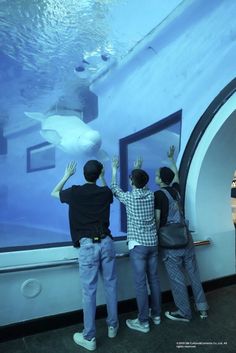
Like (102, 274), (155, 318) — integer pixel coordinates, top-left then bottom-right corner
(181, 84), (236, 279)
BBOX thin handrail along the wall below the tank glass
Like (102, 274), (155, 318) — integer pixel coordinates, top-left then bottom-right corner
(0, 239), (211, 274)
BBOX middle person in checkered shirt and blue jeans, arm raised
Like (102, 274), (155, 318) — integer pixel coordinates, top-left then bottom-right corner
(111, 158), (161, 333)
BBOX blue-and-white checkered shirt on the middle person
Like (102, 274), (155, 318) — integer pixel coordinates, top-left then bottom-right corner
(111, 183), (157, 246)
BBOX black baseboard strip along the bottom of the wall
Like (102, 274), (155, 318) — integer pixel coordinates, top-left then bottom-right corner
(0, 275), (236, 342)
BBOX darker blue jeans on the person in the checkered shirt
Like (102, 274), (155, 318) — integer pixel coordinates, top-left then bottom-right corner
(130, 245), (161, 323)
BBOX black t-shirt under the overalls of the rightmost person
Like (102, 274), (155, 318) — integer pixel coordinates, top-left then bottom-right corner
(154, 183), (180, 227)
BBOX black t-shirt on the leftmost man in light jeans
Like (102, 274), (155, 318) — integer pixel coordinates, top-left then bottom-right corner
(60, 183), (113, 247)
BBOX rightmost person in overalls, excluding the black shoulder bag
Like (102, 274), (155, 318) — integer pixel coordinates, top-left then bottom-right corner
(155, 146), (208, 322)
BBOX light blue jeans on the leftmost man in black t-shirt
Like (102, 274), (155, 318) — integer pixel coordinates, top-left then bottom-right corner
(78, 236), (118, 340)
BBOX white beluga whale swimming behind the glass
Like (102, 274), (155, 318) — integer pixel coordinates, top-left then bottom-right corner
(25, 112), (107, 160)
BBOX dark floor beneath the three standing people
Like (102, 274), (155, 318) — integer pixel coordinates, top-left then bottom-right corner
(0, 285), (236, 353)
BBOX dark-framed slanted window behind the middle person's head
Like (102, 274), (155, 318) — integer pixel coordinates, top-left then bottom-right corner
(120, 111), (182, 232)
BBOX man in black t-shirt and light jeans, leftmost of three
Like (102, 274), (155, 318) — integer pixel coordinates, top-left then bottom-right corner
(51, 160), (118, 351)
